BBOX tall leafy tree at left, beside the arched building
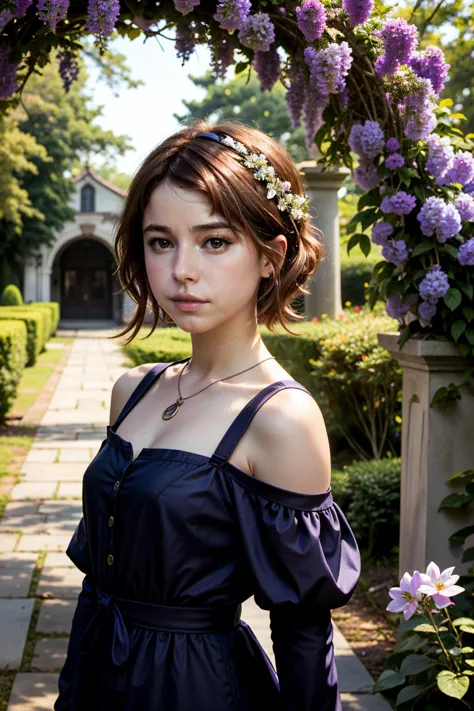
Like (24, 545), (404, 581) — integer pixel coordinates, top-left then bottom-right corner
(0, 51), (130, 286)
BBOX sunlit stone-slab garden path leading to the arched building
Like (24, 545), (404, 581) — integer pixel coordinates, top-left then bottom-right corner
(0, 331), (390, 711)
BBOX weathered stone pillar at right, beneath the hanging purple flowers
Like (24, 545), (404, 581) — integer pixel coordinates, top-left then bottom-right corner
(378, 333), (474, 577)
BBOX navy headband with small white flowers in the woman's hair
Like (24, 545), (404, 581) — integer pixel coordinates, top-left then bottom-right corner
(196, 131), (309, 220)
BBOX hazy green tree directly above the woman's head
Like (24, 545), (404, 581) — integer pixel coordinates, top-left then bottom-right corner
(173, 71), (308, 162)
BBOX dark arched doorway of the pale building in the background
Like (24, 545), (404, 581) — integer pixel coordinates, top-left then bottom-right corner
(59, 239), (115, 319)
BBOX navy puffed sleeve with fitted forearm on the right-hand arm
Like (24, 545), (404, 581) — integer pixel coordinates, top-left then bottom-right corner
(234, 479), (361, 711)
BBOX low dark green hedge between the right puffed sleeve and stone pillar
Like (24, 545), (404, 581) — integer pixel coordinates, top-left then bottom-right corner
(331, 457), (401, 558)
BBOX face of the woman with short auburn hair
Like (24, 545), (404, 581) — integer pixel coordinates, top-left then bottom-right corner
(142, 178), (286, 333)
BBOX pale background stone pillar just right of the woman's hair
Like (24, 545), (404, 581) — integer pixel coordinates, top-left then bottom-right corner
(298, 160), (350, 319)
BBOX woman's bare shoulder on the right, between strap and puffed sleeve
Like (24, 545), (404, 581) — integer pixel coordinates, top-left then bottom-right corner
(249, 388), (331, 494)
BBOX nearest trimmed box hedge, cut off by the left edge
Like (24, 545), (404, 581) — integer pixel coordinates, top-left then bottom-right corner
(0, 320), (27, 421)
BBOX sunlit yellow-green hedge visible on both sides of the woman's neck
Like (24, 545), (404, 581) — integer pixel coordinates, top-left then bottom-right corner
(123, 307), (402, 459)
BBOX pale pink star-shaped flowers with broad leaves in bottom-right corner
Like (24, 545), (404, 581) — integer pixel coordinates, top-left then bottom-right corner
(373, 561), (474, 711)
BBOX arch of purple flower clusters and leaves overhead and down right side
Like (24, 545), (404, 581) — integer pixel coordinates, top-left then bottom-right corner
(0, 0), (474, 356)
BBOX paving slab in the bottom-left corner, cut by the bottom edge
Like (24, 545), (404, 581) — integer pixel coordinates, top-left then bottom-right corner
(7, 672), (58, 711)
